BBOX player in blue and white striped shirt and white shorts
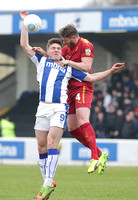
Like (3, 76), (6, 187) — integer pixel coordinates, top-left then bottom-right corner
(20, 11), (124, 200)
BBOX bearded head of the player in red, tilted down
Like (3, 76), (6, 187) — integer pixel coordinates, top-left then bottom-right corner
(59, 24), (79, 48)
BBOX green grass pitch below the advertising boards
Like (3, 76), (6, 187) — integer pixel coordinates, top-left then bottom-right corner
(0, 165), (138, 200)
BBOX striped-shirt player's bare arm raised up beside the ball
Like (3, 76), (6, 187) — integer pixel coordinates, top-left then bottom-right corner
(20, 11), (35, 58)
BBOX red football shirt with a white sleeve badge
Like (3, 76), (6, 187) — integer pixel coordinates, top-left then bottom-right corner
(62, 37), (94, 89)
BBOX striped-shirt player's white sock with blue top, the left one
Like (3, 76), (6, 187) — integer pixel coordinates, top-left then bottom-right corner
(39, 153), (47, 180)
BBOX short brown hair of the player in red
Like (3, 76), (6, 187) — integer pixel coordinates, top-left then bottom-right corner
(59, 24), (79, 38)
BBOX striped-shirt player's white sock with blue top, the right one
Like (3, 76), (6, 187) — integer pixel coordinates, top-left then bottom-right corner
(44, 149), (59, 187)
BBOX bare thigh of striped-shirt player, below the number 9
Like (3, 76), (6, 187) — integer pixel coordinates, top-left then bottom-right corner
(47, 126), (64, 149)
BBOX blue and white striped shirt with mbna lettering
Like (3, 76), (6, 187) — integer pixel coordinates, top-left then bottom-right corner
(31, 53), (87, 103)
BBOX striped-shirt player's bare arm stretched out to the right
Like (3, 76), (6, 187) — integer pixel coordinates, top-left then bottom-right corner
(83, 62), (125, 82)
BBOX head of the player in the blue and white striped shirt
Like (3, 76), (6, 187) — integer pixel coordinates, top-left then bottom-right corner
(46, 38), (62, 61)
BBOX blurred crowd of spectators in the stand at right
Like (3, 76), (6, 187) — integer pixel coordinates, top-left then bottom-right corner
(90, 63), (138, 139)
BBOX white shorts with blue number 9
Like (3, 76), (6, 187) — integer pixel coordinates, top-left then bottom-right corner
(34, 102), (68, 131)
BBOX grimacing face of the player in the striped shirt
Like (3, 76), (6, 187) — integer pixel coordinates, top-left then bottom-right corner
(47, 43), (62, 61)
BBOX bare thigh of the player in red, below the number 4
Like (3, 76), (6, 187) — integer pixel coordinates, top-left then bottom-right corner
(76, 107), (90, 126)
